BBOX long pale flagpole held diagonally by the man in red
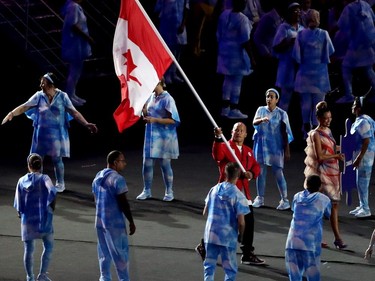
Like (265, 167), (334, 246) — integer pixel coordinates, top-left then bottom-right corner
(136, 0), (250, 173)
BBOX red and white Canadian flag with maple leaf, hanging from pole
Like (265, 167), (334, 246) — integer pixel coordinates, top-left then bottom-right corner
(113, 0), (172, 132)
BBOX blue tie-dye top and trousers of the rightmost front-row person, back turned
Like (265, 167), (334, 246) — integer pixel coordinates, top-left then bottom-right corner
(285, 190), (331, 281)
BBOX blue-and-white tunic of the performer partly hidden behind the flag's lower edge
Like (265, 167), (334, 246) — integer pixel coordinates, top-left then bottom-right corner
(143, 91), (180, 159)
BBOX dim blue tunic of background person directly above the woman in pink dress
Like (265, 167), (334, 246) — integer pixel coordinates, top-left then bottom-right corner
(293, 28), (334, 94)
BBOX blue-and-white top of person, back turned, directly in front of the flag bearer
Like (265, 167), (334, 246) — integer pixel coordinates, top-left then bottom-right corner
(204, 182), (250, 248)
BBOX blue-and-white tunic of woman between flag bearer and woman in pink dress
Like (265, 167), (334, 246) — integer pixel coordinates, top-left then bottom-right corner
(253, 106), (293, 168)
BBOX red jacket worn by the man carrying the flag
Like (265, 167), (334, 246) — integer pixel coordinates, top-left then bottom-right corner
(212, 140), (260, 200)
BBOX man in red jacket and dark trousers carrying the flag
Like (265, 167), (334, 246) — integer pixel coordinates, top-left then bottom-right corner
(212, 122), (265, 265)
